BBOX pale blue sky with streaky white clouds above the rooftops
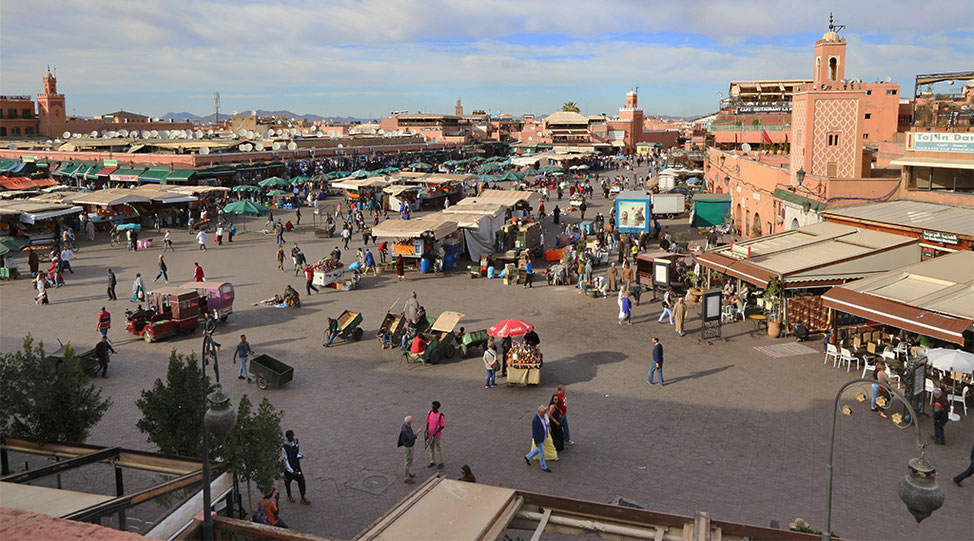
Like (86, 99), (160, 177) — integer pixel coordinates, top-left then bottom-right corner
(0, 0), (974, 117)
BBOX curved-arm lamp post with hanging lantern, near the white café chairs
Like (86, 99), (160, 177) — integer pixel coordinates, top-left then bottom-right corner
(822, 378), (944, 541)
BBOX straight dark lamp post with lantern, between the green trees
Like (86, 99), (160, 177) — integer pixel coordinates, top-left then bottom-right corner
(200, 327), (237, 539)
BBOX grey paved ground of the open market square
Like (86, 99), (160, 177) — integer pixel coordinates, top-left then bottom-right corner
(0, 187), (974, 539)
